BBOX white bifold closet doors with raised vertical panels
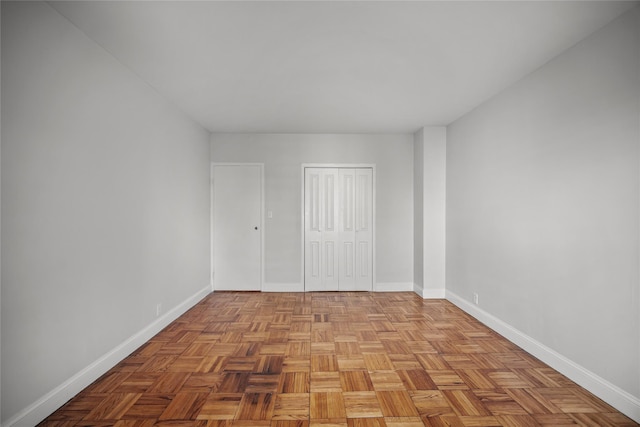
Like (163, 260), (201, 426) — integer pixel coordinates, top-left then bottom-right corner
(304, 168), (373, 291)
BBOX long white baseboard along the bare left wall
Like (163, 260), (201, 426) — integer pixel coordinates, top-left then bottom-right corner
(4, 285), (211, 427)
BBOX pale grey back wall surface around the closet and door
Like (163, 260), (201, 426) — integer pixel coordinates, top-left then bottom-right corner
(211, 134), (413, 284)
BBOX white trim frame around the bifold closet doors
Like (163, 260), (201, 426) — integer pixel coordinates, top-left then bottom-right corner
(300, 163), (378, 292)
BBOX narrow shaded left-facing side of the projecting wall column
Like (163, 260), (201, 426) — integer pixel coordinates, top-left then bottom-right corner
(413, 128), (424, 294)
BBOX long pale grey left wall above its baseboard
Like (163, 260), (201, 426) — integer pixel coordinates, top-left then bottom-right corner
(1, 2), (209, 420)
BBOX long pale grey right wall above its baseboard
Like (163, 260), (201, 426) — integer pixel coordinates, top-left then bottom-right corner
(446, 8), (640, 397)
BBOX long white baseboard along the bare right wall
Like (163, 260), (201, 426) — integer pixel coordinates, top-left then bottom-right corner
(446, 290), (640, 423)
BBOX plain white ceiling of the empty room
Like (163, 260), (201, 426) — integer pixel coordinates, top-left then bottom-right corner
(50, 1), (637, 133)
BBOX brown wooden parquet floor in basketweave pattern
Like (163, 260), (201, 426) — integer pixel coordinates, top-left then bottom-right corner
(41, 292), (638, 427)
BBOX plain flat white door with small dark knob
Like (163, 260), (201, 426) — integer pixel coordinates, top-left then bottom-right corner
(212, 165), (262, 291)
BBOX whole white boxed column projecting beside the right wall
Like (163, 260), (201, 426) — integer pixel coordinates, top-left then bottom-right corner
(414, 126), (447, 298)
